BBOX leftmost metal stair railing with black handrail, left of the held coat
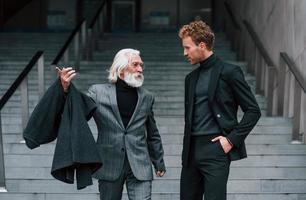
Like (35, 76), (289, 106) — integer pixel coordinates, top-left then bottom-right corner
(0, 51), (45, 192)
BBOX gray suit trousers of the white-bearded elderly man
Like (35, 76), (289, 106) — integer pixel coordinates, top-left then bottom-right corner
(99, 156), (152, 200)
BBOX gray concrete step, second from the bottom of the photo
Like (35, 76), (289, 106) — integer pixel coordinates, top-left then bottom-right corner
(3, 179), (306, 194)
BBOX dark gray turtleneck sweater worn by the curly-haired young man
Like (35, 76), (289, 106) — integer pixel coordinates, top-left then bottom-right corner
(191, 54), (221, 136)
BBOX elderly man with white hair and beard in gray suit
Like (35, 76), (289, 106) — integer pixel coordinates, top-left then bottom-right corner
(57, 49), (165, 200)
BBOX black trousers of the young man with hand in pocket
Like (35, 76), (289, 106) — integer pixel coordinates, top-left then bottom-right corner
(180, 135), (230, 200)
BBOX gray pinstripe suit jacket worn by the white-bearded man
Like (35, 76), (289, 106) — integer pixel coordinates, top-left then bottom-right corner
(87, 84), (165, 181)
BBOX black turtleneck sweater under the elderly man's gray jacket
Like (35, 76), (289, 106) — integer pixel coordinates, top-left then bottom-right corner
(116, 78), (138, 127)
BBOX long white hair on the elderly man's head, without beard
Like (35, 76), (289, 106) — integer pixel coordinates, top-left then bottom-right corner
(108, 49), (140, 83)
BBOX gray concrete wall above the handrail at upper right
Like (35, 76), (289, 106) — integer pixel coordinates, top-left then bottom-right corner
(228, 0), (306, 80)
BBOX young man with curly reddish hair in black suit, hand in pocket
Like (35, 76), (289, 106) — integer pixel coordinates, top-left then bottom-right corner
(179, 21), (261, 200)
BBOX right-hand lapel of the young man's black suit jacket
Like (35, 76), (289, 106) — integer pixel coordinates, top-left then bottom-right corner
(208, 59), (223, 103)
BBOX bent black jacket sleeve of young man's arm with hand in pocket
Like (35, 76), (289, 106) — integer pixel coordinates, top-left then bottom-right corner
(227, 67), (261, 147)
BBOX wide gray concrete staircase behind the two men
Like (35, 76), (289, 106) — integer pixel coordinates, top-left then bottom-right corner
(0, 33), (306, 200)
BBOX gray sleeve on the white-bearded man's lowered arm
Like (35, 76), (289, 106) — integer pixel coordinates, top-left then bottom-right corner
(146, 96), (166, 171)
